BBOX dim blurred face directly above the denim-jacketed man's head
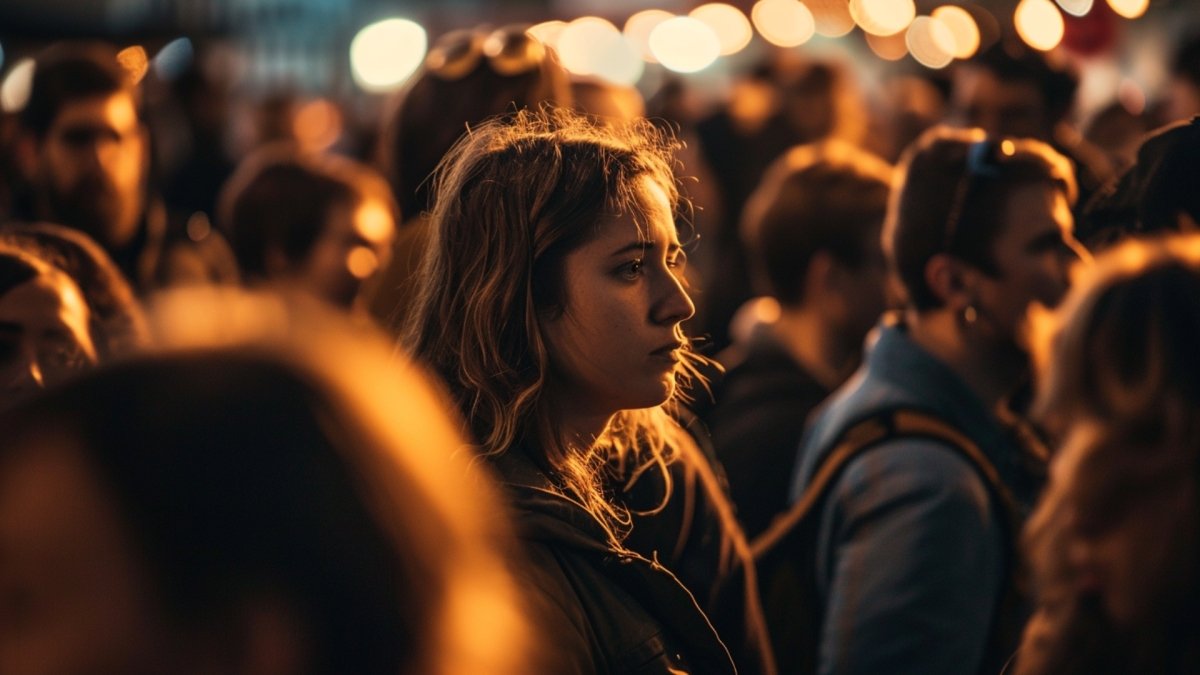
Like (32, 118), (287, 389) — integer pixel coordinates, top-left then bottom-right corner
(956, 68), (1051, 141)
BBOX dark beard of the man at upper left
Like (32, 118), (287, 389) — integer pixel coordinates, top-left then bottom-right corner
(42, 177), (137, 250)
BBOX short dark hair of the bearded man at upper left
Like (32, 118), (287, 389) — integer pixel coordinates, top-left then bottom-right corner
(19, 42), (139, 139)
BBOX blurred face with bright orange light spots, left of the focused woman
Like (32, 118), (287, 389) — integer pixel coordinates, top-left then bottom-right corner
(299, 194), (396, 307)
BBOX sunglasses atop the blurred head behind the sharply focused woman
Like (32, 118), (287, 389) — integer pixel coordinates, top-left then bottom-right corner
(425, 24), (548, 80)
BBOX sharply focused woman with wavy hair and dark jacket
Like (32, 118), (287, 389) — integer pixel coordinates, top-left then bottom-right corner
(406, 109), (748, 674)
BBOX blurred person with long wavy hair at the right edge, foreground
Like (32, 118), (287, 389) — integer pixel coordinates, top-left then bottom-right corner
(1015, 237), (1200, 675)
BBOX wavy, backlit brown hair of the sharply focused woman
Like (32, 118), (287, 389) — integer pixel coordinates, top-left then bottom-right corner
(402, 107), (702, 545)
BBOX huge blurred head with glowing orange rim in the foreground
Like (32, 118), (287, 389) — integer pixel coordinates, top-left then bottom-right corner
(0, 291), (528, 675)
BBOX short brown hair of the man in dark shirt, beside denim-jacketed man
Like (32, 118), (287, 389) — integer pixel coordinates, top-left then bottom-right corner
(742, 141), (892, 305)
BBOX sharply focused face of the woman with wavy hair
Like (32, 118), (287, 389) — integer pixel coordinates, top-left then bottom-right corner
(542, 178), (695, 417)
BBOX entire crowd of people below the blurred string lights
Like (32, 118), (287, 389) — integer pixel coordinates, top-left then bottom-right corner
(0, 25), (1200, 675)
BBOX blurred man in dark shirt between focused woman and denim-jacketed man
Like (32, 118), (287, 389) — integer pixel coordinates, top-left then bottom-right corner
(709, 141), (892, 538)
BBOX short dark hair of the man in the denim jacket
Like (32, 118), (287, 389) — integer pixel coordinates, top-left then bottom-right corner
(883, 126), (1078, 310)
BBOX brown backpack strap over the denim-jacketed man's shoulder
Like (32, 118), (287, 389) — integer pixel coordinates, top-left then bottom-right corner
(750, 407), (1021, 560)
